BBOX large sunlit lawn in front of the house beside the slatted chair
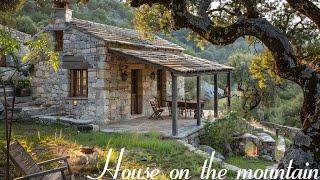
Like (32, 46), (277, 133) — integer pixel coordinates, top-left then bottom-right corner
(0, 123), (232, 179)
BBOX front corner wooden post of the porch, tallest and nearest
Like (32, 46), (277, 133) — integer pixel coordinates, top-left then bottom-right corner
(171, 73), (178, 136)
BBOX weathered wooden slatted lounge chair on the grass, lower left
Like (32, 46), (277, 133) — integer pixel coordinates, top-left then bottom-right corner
(3, 141), (72, 180)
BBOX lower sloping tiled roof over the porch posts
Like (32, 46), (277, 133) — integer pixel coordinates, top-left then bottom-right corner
(109, 48), (233, 76)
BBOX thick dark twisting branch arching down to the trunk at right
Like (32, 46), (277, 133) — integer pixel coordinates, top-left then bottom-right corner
(130, 0), (320, 127)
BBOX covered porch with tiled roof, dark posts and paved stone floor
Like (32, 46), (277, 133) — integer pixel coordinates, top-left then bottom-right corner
(109, 48), (233, 137)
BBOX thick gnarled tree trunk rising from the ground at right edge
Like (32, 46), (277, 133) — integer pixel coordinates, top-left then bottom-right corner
(278, 78), (320, 170)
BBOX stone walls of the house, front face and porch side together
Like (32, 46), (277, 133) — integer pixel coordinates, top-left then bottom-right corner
(32, 28), (184, 124)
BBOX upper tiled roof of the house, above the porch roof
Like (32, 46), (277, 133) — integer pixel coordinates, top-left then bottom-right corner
(70, 18), (184, 51)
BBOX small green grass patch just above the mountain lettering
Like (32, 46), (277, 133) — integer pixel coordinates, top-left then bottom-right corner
(226, 156), (275, 170)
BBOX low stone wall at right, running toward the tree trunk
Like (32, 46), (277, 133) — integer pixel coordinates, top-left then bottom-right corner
(260, 121), (300, 140)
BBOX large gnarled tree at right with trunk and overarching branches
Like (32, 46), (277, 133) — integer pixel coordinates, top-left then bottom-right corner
(131, 0), (320, 172)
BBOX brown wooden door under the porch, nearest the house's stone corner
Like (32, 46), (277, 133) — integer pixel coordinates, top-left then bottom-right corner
(131, 69), (143, 115)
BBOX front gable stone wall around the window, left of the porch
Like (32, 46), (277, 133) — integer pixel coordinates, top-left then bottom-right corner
(32, 29), (108, 122)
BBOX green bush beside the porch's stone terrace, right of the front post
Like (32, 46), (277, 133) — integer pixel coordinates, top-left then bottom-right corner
(201, 113), (252, 154)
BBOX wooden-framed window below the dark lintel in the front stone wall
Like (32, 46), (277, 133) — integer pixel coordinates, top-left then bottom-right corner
(70, 69), (88, 97)
